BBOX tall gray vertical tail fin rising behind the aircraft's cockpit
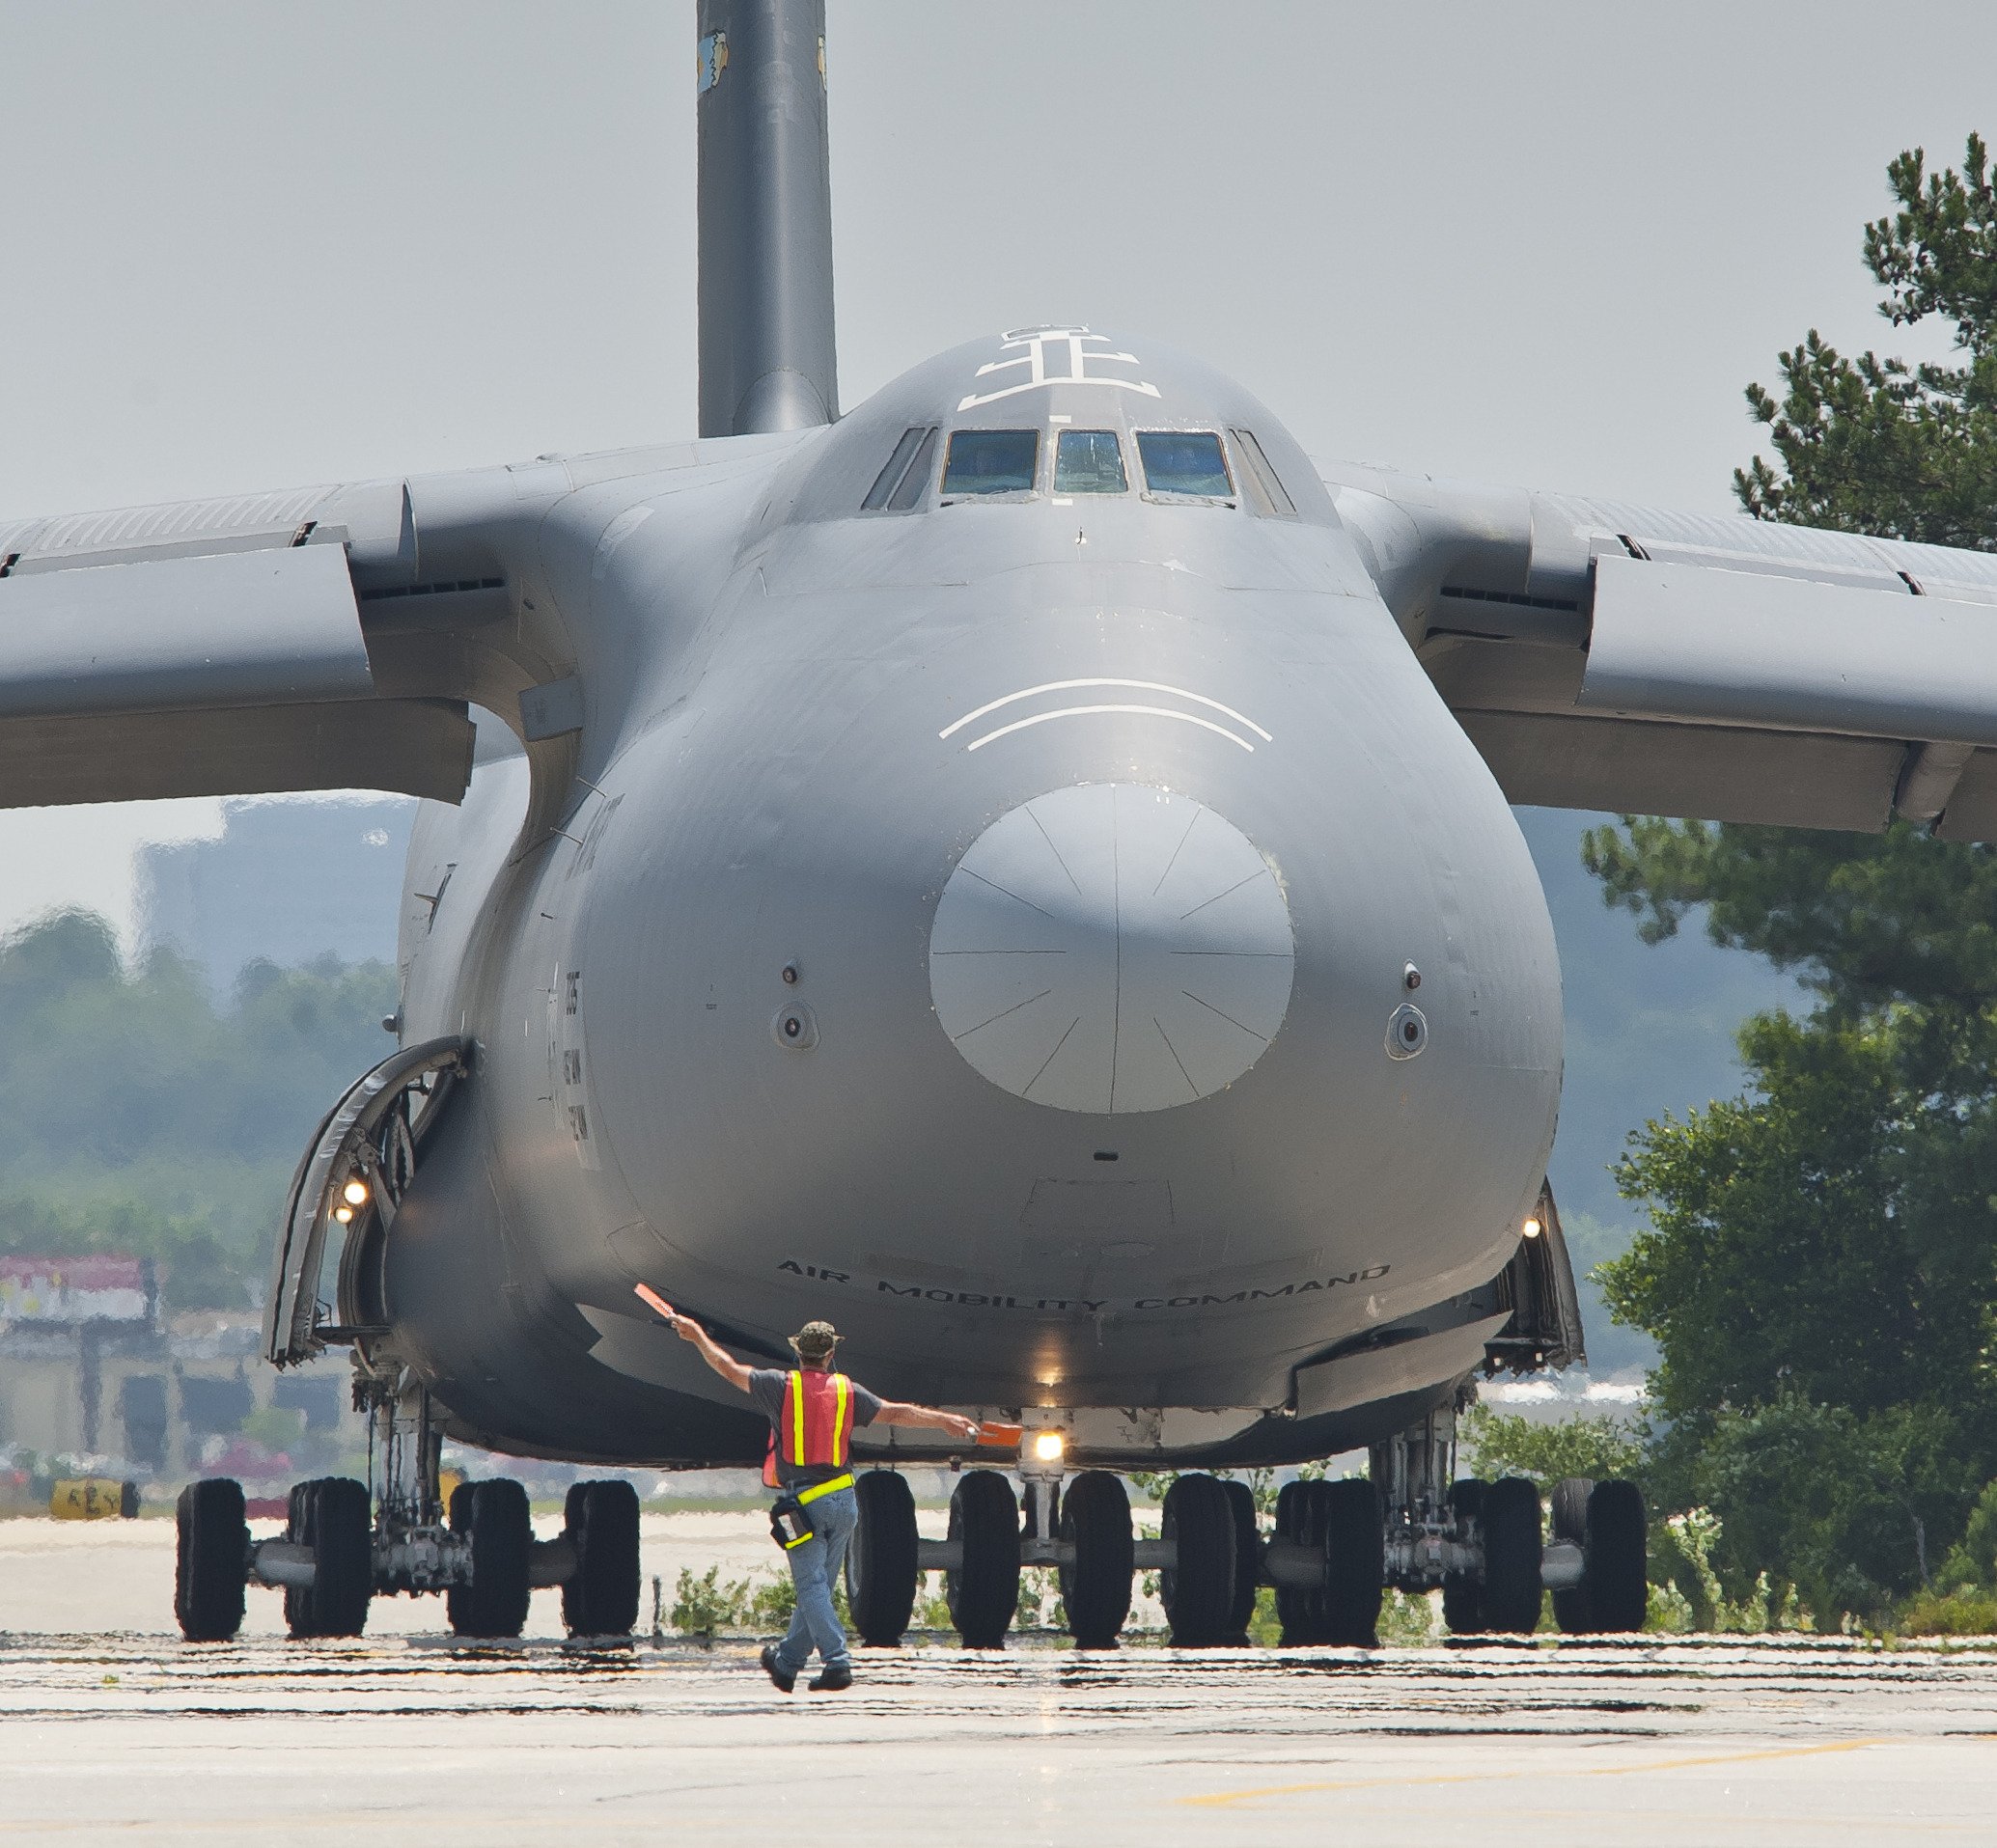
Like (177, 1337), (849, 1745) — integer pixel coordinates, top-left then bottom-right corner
(699, 0), (839, 437)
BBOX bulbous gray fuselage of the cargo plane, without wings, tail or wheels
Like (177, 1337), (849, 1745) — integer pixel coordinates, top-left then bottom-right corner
(387, 335), (1560, 1461)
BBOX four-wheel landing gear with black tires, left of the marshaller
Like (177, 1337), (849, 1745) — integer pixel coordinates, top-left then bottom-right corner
(174, 1373), (643, 1642)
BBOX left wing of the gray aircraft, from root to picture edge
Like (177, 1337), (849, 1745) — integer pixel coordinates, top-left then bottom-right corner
(0, 443), (703, 809)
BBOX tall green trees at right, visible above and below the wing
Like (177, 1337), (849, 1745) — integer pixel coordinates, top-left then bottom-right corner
(1584, 138), (1997, 1614)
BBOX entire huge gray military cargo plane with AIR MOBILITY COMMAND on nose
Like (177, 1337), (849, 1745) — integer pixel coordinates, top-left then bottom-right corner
(0, 0), (1997, 1646)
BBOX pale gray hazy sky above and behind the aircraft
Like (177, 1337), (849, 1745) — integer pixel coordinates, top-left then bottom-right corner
(0, 0), (1997, 928)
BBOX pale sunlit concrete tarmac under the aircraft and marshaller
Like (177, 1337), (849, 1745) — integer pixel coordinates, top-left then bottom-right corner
(0, 1515), (1997, 1848)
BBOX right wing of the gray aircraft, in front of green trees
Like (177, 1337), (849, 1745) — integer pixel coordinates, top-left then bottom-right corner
(1318, 463), (1997, 841)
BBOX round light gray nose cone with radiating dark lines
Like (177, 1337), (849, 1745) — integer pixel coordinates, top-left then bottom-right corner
(929, 783), (1294, 1116)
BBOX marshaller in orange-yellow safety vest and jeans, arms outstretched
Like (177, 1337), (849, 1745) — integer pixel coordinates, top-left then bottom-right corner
(673, 1313), (979, 1695)
